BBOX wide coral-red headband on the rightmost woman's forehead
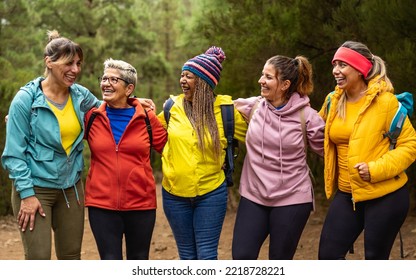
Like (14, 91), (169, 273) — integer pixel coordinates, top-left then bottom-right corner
(332, 47), (373, 78)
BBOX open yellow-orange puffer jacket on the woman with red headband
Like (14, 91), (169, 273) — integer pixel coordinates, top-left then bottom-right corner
(319, 79), (416, 202)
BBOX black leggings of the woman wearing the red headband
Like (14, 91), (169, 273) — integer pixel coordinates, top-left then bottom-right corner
(318, 187), (409, 260)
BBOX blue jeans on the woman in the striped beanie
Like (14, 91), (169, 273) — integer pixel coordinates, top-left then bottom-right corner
(162, 182), (228, 260)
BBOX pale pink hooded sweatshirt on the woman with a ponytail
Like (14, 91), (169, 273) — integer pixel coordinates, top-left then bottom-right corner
(234, 93), (325, 207)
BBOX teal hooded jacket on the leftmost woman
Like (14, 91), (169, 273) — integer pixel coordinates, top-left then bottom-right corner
(1, 77), (100, 199)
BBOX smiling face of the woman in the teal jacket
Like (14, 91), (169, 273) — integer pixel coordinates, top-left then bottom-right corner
(45, 54), (82, 87)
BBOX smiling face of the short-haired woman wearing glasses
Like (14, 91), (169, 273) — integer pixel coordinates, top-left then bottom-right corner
(100, 68), (134, 108)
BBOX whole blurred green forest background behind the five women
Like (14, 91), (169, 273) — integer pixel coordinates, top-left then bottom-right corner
(0, 0), (416, 216)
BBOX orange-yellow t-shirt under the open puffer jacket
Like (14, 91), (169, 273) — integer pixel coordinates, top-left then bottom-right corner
(329, 98), (365, 193)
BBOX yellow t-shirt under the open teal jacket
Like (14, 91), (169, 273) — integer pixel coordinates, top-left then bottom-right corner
(46, 95), (81, 155)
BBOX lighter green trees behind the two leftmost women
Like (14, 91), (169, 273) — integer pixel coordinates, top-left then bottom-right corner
(0, 0), (193, 215)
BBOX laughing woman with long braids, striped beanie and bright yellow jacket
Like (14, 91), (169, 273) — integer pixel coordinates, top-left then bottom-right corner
(159, 46), (247, 260)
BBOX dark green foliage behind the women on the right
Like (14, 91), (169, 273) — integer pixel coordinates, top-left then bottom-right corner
(192, 0), (416, 201)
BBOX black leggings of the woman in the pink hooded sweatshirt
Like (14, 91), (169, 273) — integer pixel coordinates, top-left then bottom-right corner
(232, 197), (312, 260)
